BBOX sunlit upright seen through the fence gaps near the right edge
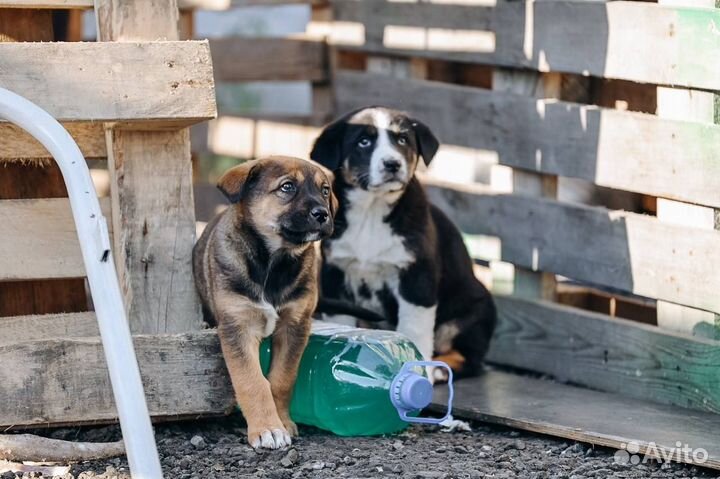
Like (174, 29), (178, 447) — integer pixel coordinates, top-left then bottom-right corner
(657, 0), (720, 338)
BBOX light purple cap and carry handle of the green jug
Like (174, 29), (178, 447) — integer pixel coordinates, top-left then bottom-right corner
(390, 361), (453, 424)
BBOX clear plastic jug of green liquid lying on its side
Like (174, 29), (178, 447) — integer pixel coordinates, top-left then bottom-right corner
(260, 321), (452, 436)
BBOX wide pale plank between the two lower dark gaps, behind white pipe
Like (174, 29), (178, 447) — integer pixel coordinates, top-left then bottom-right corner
(0, 198), (110, 282)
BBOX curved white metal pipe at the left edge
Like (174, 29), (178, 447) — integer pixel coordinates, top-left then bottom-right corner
(0, 88), (162, 479)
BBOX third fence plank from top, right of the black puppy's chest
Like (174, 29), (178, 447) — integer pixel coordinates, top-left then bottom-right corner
(427, 182), (720, 312)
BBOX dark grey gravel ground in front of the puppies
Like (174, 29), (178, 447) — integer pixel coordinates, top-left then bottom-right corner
(7, 417), (720, 479)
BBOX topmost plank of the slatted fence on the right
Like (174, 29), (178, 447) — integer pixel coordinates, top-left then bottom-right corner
(331, 0), (720, 89)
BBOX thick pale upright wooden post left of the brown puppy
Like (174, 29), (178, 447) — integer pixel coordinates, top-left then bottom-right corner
(95, 0), (201, 334)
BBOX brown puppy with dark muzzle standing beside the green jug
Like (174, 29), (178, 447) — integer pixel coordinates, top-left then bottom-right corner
(193, 157), (337, 449)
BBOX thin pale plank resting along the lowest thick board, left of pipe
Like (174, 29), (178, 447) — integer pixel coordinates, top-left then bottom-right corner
(0, 312), (100, 347)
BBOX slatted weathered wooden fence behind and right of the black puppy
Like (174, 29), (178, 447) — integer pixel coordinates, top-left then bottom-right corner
(318, 0), (720, 420)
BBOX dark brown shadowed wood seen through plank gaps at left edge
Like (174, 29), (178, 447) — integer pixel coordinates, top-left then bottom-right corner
(0, 8), (88, 317)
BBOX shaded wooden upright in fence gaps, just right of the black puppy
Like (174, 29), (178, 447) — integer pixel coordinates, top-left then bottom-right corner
(493, 68), (561, 300)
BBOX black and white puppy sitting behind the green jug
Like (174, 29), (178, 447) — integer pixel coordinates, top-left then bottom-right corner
(310, 107), (496, 376)
